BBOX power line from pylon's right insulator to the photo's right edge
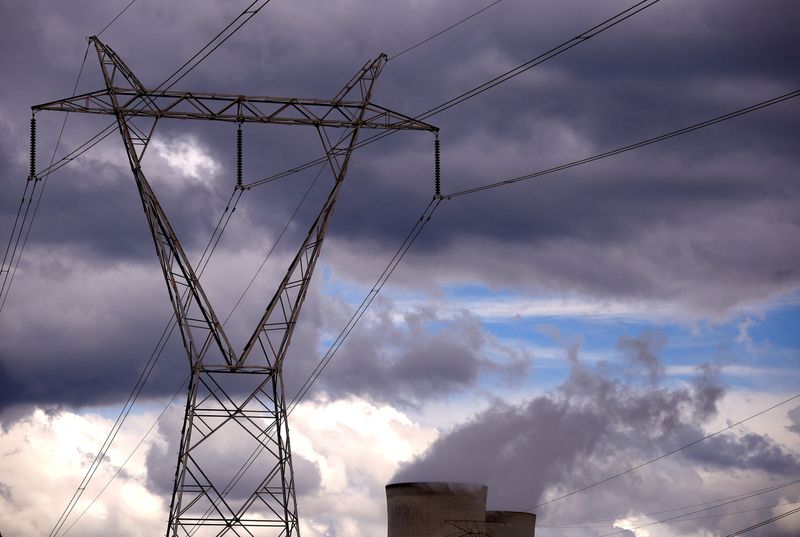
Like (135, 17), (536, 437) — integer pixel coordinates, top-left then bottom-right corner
(444, 90), (800, 199)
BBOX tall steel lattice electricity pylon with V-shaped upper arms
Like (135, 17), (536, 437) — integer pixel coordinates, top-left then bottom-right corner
(33, 37), (438, 537)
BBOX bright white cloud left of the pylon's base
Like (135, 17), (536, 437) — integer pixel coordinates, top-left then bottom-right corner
(0, 410), (166, 537)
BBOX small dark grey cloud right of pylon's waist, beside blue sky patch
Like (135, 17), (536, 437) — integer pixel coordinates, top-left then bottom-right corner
(312, 301), (532, 406)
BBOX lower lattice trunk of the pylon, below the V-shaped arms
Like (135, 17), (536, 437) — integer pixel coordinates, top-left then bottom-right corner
(167, 369), (299, 537)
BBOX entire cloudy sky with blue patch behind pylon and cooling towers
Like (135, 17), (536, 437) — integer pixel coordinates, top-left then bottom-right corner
(0, 0), (800, 537)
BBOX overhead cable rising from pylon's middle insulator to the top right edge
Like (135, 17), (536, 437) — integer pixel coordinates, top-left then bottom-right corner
(245, 0), (661, 188)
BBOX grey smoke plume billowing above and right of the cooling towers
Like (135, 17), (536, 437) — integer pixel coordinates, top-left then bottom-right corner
(393, 334), (800, 535)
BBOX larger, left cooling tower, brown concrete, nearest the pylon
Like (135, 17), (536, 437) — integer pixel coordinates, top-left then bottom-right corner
(386, 483), (488, 537)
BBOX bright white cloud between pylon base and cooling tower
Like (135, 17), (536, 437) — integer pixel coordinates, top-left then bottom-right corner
(291, 398), (437, 537)
